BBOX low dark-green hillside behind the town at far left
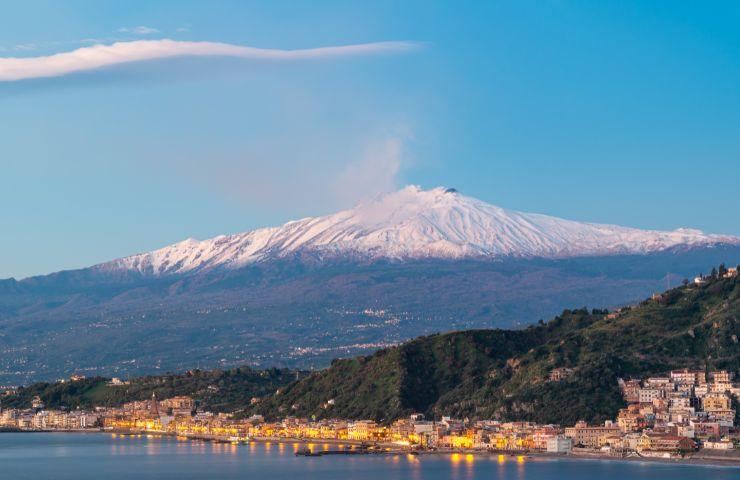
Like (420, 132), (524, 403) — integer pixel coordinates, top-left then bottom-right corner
(0, 367), (300, 412)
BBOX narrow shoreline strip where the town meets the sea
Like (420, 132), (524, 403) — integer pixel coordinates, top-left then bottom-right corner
(5, 429), (740, 468)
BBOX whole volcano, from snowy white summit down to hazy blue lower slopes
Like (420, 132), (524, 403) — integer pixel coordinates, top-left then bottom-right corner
(0, 187), (740, 385)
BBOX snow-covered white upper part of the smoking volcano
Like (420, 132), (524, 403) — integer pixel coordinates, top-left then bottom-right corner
(105, 186), (740, 275)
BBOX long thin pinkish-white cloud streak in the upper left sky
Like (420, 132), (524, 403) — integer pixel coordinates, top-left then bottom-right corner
(0, 40), (418, 82)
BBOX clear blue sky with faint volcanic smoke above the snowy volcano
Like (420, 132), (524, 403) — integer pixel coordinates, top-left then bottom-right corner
(0, 0), (740, 278)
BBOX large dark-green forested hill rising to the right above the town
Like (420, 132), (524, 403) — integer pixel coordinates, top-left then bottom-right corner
(250, 277), (740, 424)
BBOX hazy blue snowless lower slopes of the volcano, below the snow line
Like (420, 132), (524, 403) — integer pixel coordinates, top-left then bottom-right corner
(0, 247), (740, 385)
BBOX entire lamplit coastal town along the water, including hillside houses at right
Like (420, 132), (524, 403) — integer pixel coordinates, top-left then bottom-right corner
(0, 368), (740, 461)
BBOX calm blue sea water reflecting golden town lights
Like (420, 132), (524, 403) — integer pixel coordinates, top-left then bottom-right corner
(0, 433), (740, 480)
